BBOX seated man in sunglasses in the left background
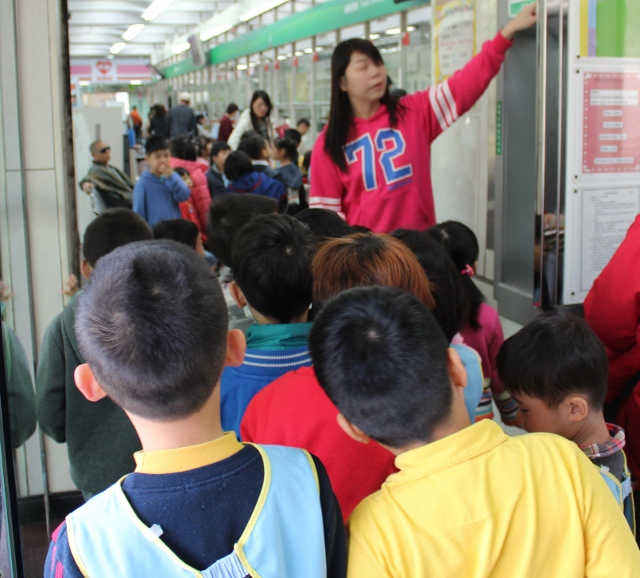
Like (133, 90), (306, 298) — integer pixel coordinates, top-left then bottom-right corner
(79, 140), (133, 209)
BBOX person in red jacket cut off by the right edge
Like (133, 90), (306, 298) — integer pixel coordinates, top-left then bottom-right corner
(584, 216), (640, 480)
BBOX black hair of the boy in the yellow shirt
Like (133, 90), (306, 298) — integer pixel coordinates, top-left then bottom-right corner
(309, 287), (453, 448)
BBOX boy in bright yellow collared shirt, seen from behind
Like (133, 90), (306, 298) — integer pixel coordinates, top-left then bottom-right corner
(309, 287), (640, 578)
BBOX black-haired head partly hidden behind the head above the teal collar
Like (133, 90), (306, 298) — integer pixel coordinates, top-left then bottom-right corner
(207, 194), (278, 267)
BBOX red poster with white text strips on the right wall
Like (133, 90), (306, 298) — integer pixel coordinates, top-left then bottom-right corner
(582, 72), (640, 174)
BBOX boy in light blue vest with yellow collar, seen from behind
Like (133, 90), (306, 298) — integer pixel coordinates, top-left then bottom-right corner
(45, 241), (346, 578)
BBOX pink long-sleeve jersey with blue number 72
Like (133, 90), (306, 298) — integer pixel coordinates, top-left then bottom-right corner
(309, 33), (512, 232)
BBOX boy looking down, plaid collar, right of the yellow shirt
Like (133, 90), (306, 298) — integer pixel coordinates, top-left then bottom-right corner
(497, 312), (635, 534)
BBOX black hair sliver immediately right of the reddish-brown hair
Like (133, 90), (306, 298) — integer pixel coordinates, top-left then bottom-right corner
(392, 229), (469, 341)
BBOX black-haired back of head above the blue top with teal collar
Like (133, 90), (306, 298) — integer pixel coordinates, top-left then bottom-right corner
(232, 215), (313, 323)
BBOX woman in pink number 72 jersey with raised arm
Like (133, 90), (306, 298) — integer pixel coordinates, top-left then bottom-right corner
(309, 4), (536, 232)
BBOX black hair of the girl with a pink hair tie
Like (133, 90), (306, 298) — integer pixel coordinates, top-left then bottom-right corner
(427, 221), (485, 329)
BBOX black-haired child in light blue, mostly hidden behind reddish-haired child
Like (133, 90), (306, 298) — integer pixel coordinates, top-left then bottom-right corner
(391, 229), (483, 421)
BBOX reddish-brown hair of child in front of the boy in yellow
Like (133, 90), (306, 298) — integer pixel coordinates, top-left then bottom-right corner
(312, 233), (434, 309)
